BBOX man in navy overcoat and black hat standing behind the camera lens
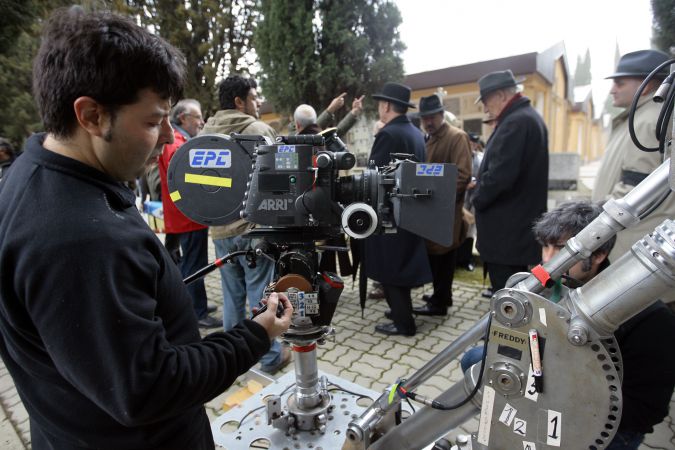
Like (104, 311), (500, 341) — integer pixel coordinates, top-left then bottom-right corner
(365, 83), (432, 336)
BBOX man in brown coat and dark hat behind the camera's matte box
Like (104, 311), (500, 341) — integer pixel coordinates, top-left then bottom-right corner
(413, 95), (471, 316)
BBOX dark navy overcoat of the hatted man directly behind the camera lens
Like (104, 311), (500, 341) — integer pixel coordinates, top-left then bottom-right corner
(364, 116), (432, 286)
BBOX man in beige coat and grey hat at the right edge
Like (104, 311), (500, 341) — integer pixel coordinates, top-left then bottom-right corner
(592, 50), (675, 268)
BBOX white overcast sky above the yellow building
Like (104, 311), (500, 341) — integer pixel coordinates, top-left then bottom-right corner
(396, 0), (652, 109)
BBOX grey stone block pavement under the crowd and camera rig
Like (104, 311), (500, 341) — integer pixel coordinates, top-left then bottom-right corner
(0, 255), (675, 450)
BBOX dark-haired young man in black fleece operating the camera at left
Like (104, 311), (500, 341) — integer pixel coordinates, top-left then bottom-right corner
(0, 7), (292, 450)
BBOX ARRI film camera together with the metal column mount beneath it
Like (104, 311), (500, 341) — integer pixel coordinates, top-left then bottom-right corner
(168, 132), (457, 442)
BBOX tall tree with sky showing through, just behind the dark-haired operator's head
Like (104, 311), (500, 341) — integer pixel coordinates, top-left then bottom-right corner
(117, 0), (259, 114)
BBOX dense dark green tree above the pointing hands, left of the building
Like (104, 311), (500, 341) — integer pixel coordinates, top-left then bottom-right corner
(255, 0), (405, 118)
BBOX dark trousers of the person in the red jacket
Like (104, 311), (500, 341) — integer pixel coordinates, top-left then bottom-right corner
(177, 228), (209, 319)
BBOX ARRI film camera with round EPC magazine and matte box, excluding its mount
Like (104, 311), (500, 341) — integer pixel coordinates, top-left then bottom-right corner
(168, 130), (457, 246)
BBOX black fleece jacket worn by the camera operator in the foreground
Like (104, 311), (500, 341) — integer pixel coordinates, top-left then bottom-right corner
(0, 135), (270, 449)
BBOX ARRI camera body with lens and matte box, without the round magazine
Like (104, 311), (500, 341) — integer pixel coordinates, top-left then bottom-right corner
(241, 134), (457, 245)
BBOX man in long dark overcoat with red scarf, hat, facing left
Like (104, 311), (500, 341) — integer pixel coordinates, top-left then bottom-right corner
(473, 70), (548, 292)
